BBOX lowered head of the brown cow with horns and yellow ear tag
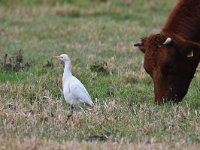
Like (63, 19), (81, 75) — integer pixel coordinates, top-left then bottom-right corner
(135, 33), (200, 102)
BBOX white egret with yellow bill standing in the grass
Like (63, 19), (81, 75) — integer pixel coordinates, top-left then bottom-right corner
(53, 54), (93, 117)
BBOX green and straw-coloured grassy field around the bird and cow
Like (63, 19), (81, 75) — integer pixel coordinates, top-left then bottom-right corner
(0, 0), (200, 150)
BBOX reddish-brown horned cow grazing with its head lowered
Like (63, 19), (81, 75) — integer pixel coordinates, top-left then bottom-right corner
(135, 0), (200, 102)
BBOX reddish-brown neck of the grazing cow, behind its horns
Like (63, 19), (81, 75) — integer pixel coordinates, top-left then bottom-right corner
(161, 0), (200, 42)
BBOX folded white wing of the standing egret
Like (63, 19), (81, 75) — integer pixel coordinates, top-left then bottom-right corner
(70, 76), (93, 106)
